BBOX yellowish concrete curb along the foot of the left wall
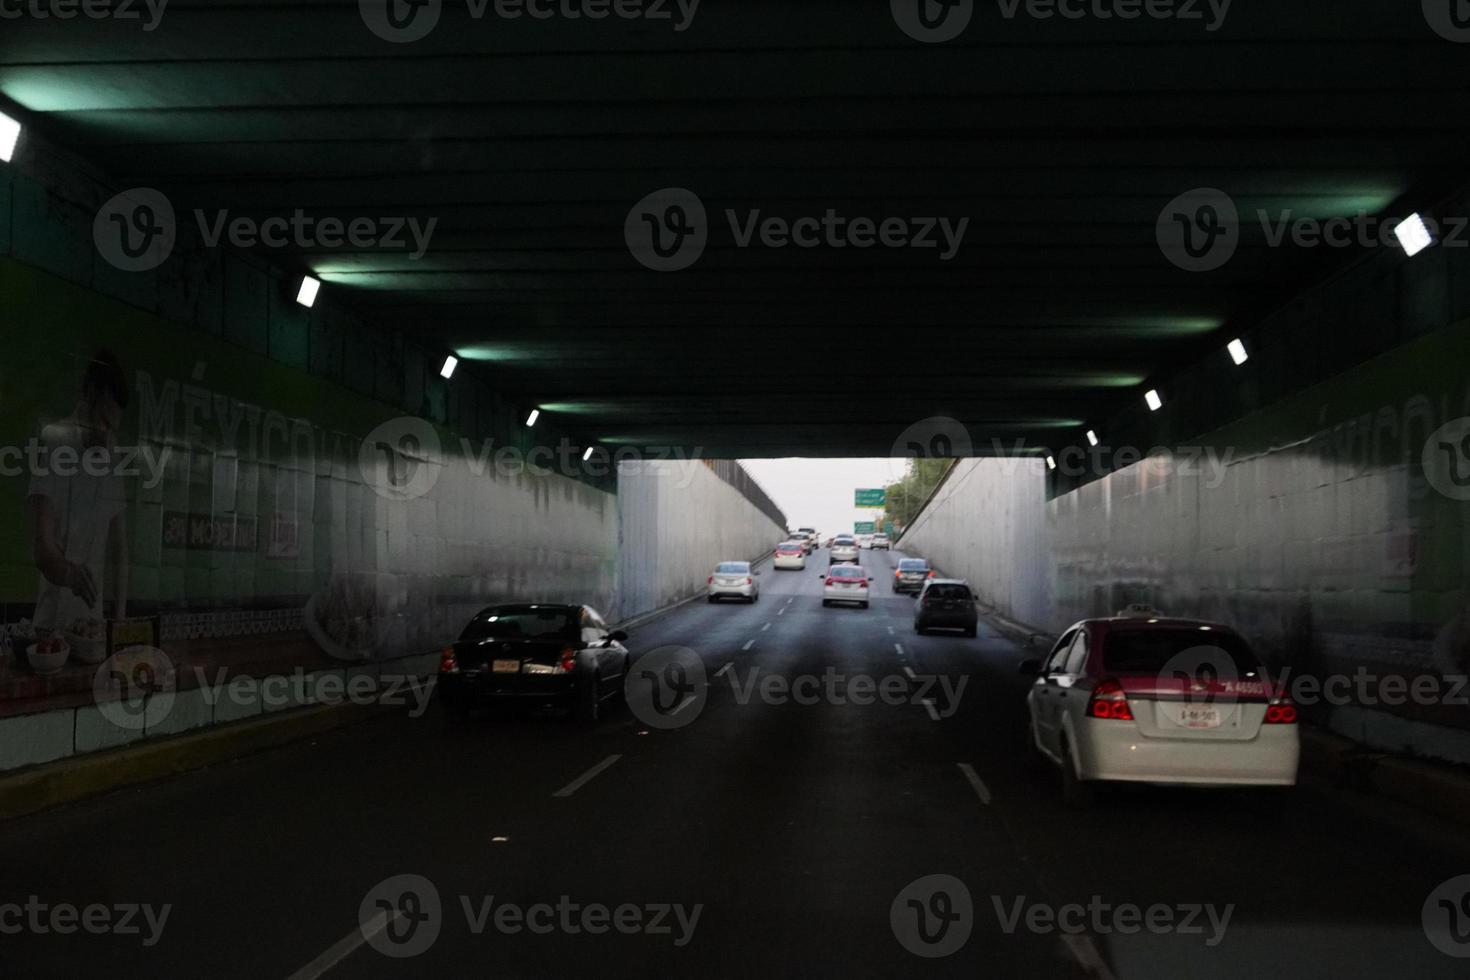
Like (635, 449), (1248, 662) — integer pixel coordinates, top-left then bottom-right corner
(0, 704), (388, 820)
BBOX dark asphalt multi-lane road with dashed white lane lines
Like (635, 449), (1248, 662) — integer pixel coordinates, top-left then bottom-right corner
(0, 552), (1470, 980)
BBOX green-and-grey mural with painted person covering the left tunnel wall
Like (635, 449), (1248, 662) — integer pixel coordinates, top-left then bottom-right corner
(0, 262), (616, 710)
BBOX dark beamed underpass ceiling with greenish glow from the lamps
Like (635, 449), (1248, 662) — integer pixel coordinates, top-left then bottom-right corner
(0, 0), (1470, 455)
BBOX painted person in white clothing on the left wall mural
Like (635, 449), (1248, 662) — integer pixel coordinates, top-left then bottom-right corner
(26, 350), (128, 663)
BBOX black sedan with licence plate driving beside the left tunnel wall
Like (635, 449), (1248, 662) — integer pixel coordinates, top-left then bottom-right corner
(438, 604), (629, 723)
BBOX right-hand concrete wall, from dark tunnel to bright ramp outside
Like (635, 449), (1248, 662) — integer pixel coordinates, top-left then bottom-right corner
(900, 323), (1470, 763)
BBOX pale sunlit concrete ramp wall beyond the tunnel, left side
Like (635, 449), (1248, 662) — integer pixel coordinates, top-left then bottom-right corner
(617, 460), (786, 619)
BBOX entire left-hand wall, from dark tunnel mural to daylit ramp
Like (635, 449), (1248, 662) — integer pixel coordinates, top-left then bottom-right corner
(0, 128), (781, 770)
